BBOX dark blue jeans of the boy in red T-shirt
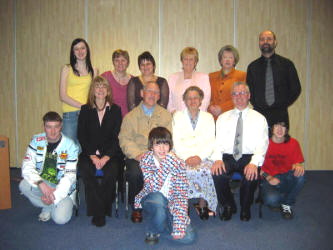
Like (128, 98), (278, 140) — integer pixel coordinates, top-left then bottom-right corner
(262, 171), (305, 207)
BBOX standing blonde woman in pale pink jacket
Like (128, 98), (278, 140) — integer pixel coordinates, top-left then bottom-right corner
(168, 47), (211, 113)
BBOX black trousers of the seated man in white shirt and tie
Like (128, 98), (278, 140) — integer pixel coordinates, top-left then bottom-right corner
(213, 154), (258, 209)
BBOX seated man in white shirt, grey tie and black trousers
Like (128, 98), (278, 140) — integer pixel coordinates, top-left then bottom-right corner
(211, 82), (268, 221)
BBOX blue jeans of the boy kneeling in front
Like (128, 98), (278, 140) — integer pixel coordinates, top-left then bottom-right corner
(141, 192), (196, 244)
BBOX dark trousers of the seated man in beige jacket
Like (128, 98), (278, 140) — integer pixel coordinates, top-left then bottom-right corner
(125, 159), (143, 208)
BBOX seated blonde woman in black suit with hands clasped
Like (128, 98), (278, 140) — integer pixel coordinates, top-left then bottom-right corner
(78, 76), (122, 226)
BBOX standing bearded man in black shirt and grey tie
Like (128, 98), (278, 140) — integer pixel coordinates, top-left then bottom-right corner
(246, 30), (301, 127)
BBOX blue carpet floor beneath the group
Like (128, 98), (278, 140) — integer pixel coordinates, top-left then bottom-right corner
(0, 169), (333, 250)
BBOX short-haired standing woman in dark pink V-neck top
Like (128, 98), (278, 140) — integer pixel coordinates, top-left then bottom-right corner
(102, 49), (132, 117)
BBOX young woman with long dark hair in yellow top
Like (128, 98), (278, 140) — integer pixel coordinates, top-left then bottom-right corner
(60, 38), (98, 143)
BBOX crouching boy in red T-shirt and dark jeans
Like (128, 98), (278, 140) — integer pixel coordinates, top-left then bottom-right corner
(261, 122), (304, 219)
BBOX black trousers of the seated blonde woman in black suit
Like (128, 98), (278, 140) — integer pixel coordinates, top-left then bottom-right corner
(79, 156), (121, 216)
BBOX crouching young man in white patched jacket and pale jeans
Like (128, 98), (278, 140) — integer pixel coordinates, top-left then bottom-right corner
(19, 112), (79, 224)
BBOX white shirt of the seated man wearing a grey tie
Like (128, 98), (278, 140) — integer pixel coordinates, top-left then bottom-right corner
(212, 107), (268, 166)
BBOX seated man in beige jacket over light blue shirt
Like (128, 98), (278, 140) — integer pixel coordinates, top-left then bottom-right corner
(119, 82), (172, 223)
